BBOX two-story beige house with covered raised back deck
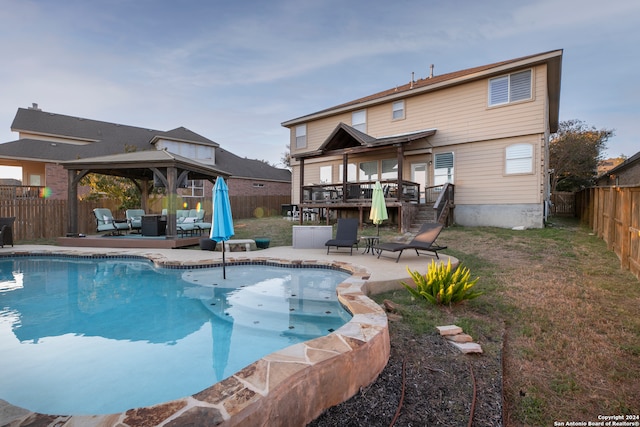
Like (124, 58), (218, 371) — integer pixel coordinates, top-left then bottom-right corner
(282, 50), (562, 230)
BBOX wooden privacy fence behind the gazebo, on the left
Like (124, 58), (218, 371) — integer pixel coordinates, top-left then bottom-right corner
(0, 196), (291, 241)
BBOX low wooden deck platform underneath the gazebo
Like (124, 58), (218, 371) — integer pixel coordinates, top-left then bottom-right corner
(57, 234), (208, 249)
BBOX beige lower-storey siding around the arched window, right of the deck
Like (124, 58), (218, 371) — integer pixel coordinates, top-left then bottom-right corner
(454, 137), (542, 205)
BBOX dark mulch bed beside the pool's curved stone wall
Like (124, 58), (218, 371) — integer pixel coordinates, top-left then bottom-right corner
(309, 316), (503, 427)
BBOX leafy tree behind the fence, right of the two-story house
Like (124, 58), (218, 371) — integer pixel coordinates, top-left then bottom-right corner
(549, 119), (614, 192)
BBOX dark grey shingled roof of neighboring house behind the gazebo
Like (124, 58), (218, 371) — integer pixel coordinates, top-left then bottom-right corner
(0, 108), (291, 182)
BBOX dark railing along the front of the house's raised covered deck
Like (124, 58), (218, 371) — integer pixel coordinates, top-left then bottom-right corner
(302, 180), (420, 203)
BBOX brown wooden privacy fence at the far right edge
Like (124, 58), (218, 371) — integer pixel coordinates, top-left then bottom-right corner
(576, 187), (640, 279)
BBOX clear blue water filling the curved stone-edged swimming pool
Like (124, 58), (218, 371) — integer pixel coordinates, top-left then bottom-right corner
(0, 257), (351, 415)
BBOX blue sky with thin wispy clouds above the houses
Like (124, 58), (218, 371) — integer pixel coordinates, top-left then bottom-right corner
(0, 0), (640, 178)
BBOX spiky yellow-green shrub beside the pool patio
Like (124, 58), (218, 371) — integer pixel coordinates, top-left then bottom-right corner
(401, 260), (482, 305)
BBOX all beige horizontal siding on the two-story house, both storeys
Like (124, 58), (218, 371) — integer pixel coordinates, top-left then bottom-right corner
(292, 65), (549, 211)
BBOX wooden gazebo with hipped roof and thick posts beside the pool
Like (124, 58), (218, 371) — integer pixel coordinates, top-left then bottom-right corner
(61, 150), (230, 239)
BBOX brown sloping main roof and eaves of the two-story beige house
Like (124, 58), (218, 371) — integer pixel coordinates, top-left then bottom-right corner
(282, 49), (562, 133)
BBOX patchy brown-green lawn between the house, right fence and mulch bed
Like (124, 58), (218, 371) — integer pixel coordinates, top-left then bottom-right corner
(236, 218), (640, 425)
